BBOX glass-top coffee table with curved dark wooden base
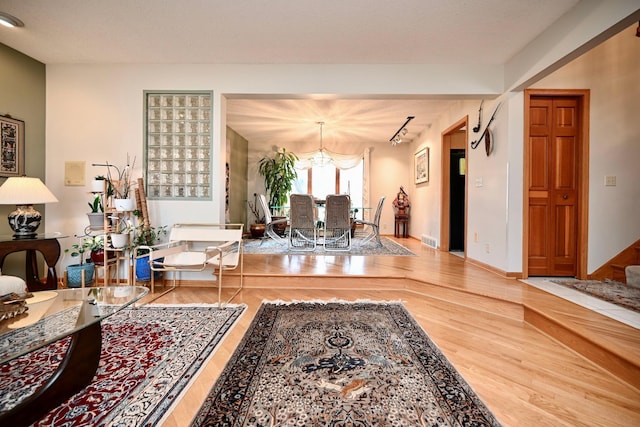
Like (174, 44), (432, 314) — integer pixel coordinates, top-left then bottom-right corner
(0, 286), (149, 426)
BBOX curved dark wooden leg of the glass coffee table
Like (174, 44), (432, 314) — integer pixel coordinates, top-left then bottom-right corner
(0, 322), (102, 426)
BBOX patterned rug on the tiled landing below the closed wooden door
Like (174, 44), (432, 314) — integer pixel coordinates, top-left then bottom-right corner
(550, 279), (640, 313)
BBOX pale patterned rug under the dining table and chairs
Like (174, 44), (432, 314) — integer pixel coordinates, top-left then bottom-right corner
(244, 237), (416, 256)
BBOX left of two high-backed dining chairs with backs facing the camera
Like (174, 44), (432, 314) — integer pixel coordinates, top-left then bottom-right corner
(289, 194), (317, 251)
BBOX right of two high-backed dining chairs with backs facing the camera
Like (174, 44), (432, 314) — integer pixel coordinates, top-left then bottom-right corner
(324, 194), (351, 251)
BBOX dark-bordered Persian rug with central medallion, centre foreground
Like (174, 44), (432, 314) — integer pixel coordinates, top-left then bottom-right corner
(192, 302), (500, 427)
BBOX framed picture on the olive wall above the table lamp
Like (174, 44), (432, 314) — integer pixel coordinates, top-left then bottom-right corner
(0, 116), (24, 177)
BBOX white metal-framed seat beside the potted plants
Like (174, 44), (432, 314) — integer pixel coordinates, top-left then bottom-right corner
(134, 224), (244, 307)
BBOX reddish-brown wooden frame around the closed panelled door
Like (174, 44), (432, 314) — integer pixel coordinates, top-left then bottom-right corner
(522, 89), (591, 280)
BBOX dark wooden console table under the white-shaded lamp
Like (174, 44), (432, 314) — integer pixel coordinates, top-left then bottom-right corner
(0, 234), (64, 292)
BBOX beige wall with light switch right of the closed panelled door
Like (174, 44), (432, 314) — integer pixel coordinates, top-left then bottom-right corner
(533, 23), (640, 273)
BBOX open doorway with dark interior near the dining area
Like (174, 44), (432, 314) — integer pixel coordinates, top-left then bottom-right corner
(440, 116), (469, 257)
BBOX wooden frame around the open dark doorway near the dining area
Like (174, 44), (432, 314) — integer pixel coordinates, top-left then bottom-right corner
(440, 115), (469, 254)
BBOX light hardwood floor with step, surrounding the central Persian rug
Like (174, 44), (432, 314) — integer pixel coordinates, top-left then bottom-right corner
(141, 239), (640, 427)
